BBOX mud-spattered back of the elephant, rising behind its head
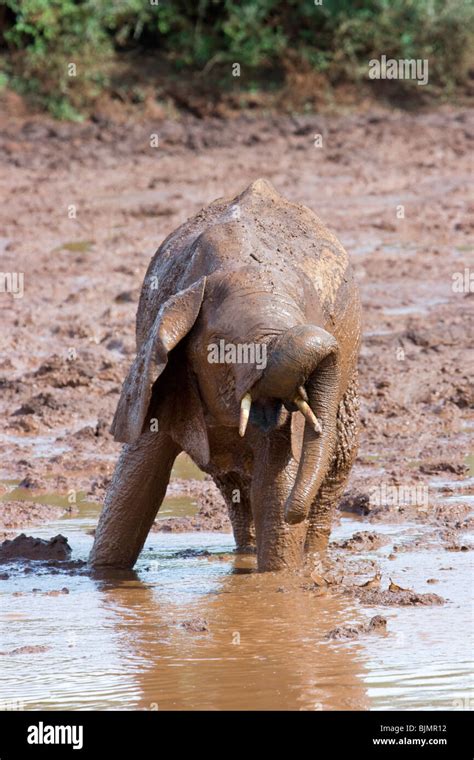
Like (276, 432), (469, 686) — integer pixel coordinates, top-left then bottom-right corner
(137, 179), (349, 345)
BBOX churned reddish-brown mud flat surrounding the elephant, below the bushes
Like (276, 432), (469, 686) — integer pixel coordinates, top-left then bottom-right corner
(0, 101), (474, 548)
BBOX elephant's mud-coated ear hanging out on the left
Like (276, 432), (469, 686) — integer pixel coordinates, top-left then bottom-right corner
(111, 277), (206, 443)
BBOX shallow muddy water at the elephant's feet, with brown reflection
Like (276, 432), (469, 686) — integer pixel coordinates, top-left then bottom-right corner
(0, 472), (472, 710)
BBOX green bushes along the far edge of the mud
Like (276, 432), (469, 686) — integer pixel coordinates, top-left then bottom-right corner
(0, 0), (474, 118)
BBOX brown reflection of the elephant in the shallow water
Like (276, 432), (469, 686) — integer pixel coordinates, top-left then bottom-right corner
(95, 559), (368, 710)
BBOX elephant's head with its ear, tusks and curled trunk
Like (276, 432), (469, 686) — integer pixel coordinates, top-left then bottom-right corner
(112, 267), (340, 523)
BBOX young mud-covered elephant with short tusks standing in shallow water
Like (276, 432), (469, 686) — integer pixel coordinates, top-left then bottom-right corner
(89, 179), (361, 571)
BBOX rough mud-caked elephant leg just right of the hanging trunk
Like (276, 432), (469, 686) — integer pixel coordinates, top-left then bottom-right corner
(305, 375), (359, 554)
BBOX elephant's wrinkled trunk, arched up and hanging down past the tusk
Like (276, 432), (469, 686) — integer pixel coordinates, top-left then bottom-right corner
(252, 325), (340, 524)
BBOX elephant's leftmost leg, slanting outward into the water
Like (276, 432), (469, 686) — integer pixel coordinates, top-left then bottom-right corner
(89, 431), (180, 568)
